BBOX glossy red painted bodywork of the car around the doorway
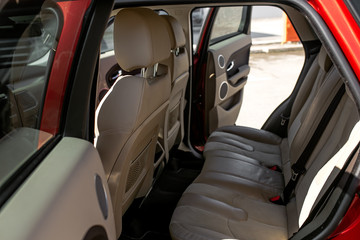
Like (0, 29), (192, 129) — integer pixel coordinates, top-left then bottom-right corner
(0, 0), (360, 240)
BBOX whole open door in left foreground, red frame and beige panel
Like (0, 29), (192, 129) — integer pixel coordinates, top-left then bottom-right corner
(0, 0), (116, 240)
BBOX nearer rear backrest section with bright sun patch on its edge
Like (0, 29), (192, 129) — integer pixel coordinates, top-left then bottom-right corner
(287, 87), (360, 235)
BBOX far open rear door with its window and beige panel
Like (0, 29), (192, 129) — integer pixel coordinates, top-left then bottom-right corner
(192, 6), (251, 140)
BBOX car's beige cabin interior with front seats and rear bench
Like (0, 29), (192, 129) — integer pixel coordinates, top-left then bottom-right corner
(95, 4), (360, 239)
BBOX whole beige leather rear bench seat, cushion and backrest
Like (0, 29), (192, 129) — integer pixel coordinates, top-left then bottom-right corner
(170, 48), (360, 240)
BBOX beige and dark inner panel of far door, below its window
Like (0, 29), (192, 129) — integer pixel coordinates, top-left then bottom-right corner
(205, 13), (251, 134)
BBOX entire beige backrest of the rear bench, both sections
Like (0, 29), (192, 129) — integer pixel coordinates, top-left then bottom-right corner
(283, 49), (360, 235)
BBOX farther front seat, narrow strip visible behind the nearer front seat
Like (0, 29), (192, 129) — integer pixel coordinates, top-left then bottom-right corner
(160, 15), (189, 160)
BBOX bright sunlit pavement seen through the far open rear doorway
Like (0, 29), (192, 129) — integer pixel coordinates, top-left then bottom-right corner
(236, 49), (304, 128)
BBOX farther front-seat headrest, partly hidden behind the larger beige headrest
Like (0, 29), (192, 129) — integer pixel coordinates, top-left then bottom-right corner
(161, 15), (186, 49)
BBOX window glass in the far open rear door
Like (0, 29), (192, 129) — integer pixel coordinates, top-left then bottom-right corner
(210, 7), (243, 41)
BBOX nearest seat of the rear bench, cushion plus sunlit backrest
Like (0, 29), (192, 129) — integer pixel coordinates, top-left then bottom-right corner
(170, 89), (360, 240)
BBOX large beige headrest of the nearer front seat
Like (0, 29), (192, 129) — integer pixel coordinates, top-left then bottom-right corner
(114, 8), (170, 72)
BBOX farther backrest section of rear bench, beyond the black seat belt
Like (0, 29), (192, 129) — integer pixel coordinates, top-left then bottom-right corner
(283, 47), (336, 173)
